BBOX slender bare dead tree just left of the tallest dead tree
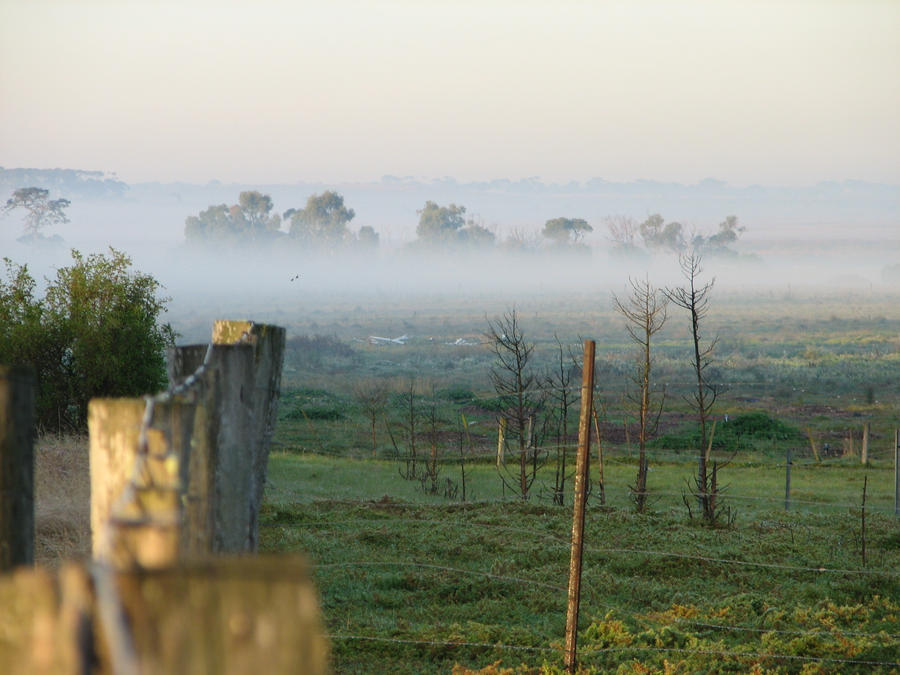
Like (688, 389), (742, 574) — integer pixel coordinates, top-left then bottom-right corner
(613, 279), (668, 513)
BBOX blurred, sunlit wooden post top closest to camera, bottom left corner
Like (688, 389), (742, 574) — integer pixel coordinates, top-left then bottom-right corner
(0, 556), (329, 675)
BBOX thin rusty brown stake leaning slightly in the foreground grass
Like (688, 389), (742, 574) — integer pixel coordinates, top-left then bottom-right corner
(565, 340), (596, 673)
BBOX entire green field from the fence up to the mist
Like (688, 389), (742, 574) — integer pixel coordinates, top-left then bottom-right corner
(251, 294), (900, 673)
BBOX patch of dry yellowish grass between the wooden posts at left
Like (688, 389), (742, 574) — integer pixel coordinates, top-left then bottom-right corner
(34, 436), (91, 568)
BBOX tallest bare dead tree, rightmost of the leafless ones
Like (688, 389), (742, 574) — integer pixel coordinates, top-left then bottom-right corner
(665, 251), (718, 523)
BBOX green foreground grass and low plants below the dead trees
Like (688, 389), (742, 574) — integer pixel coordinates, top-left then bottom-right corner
(262, 453), (900, 673)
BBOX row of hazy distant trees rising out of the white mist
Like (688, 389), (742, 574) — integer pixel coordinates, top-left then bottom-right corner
(0, 182), (745, 257)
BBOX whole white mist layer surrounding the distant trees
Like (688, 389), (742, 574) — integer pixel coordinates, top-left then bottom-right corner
(0, 170), (900, 348)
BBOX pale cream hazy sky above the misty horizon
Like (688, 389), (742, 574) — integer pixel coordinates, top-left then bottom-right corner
(0, 0), (900, 185)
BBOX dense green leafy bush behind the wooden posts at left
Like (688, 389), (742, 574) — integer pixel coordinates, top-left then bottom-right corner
(0, 248), (175, 431)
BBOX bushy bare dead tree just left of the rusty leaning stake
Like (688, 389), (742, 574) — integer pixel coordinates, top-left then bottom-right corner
(485, 309), (541, 500)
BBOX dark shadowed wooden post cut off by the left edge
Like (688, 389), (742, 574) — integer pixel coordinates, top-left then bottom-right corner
(0, 366), (34, 571)
